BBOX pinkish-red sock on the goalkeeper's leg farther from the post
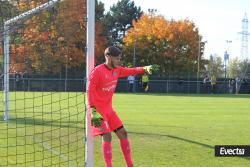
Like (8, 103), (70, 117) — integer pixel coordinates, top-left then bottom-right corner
(120, 138), (133, 167)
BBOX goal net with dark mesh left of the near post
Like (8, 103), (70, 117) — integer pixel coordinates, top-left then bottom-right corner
(0, 0), (87, 167)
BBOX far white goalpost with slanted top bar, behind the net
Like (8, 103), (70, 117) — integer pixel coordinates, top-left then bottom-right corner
(3, 0), (63, 121)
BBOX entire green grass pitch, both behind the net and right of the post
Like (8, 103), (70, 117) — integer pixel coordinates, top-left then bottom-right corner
(0, 92), (250, 167)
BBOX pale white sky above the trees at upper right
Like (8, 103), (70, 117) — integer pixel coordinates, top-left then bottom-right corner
(99, 0), (250, 58)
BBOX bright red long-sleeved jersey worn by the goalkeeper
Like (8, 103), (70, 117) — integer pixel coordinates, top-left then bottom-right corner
(87, 64), (144, 108)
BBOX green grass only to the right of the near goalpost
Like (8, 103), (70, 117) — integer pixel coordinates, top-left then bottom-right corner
(95, 94), (250, 167)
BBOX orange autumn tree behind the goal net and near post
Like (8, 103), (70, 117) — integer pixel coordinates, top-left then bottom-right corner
(10, 0), (106, 74)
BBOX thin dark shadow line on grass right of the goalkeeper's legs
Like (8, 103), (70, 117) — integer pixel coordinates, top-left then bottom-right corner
(129, 131), (250, 160)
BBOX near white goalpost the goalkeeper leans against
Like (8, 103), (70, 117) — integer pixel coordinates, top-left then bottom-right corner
(85, 0), (95, 167)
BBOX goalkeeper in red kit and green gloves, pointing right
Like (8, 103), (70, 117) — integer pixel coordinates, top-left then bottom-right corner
(87, 46), (158, 167)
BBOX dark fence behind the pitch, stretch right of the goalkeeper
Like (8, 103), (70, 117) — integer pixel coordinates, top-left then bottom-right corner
(116, 80), (250, 94)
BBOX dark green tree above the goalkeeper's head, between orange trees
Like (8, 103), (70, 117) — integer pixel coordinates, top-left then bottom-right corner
(103, 0), (142, 45)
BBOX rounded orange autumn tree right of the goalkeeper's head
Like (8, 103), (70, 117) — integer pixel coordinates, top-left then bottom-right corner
(124, 14), (205, 75)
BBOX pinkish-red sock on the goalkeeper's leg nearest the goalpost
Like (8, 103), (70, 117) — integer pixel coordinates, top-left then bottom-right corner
(102, 141), (112, 167)
